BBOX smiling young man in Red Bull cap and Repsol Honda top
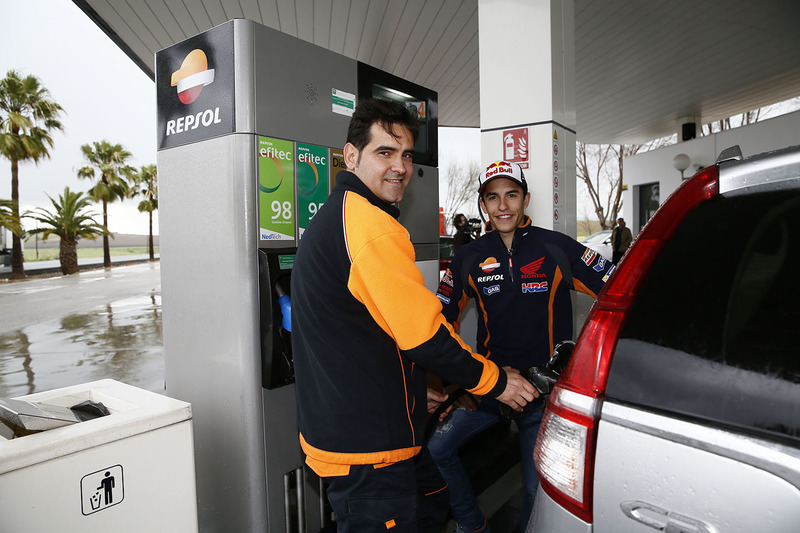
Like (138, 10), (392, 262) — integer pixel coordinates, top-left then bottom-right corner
(429, 161), (611, 532)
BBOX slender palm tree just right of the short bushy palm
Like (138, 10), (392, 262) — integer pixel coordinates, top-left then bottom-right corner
(78, 140), (136, 268)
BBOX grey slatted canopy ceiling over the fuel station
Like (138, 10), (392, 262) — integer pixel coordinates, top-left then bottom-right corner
(74, 0), (800, 143)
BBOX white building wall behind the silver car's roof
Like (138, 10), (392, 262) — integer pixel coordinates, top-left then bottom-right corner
(622, 111), (800, 236)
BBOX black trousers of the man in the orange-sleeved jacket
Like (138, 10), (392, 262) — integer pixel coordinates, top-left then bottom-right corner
(328, 448), (450, 533)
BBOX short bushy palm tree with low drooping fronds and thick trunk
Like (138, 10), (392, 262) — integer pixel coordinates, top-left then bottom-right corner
(25, 187), (108, 274)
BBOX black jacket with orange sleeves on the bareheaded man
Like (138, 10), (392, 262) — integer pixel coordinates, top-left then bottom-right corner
(291, 171), (506, 476)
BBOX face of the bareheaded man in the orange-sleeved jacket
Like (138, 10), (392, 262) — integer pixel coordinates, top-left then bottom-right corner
(344, 124), (414, 203)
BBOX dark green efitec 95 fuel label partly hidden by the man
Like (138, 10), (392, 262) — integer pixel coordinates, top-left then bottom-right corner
(297, 143), (328, 239)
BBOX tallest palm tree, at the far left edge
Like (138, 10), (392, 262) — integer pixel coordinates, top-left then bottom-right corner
(0, 70), (64, 279)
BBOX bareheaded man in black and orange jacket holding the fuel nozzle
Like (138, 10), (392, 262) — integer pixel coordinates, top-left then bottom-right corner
(291, 100), (537, 533)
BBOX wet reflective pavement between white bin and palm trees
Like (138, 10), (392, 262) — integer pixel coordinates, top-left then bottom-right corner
(0, 262), (164, 398)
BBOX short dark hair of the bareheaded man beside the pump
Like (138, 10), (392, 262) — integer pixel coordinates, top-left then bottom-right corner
(347, 98), (419, 152)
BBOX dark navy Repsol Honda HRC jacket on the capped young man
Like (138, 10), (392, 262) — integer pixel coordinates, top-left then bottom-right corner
(436, 216), (612, 368)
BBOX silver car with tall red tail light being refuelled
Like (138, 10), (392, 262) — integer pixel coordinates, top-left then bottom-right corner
(527, 143), (800, 533)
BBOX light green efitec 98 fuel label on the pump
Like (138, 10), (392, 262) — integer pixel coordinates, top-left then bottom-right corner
(257, 136), (295, 241)
